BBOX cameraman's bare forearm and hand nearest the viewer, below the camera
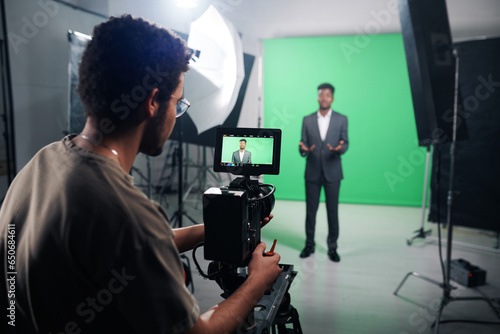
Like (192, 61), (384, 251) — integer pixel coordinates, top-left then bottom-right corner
(187, 243), (282, 334)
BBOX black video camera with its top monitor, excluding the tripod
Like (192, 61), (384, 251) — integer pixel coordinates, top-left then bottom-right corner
(203, 127), (281, 271)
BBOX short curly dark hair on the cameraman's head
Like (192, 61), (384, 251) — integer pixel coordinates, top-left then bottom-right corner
(77, 15), (191, 126)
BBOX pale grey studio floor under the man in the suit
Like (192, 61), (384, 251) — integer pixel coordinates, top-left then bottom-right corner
(177, 201), (500, 334)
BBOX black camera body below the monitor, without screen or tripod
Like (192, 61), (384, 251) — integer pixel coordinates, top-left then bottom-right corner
(203, 177), (275, 267)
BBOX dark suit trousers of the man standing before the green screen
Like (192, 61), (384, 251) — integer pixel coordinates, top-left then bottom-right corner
(306, 176), (340, 250)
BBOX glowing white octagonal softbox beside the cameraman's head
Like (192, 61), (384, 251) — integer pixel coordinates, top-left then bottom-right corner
(184, 5), (245, 134)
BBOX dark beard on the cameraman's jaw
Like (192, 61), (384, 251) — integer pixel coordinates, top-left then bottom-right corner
(139, 103), (168, 157)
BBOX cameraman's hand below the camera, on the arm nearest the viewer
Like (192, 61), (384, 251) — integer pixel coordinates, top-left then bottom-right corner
(248, 242), (283, 292)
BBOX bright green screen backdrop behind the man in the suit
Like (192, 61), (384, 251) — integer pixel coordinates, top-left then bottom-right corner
(263, 34), (426, 206)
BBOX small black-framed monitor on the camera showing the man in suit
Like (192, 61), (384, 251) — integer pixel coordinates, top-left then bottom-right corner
(214, 127), (281, 175)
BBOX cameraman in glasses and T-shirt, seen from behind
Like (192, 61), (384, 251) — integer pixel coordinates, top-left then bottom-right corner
(0, 16), (281, 333)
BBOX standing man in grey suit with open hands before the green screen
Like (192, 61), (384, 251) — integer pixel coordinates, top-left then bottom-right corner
(299, 83), (349, 262)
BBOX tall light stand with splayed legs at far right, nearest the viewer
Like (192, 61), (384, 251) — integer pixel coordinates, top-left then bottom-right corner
(394, 49), (500, 334)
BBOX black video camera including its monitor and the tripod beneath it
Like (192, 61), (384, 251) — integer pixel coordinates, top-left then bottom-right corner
(193, 127), (302, 334)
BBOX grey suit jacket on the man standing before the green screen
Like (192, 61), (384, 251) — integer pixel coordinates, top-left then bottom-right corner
(299, 110), (349, 181)
